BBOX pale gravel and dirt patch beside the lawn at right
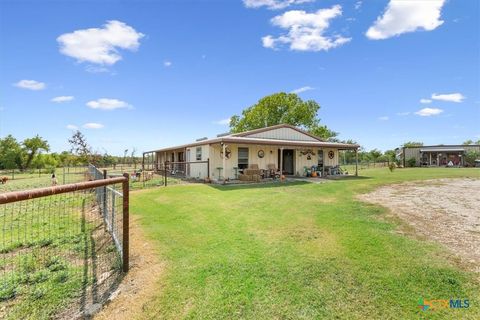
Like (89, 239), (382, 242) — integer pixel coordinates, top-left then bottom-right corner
(359, 179), (480, 273)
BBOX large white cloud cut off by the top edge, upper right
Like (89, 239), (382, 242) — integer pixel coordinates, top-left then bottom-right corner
(366, 0), (445, 40)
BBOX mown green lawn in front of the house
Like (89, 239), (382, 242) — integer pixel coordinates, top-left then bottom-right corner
(131, 168), (480, 319)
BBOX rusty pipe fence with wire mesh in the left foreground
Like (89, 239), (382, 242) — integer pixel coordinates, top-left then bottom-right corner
(0, 175), (129, 319)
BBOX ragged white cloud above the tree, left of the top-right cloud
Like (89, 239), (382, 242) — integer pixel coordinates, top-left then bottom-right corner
(262, 5), (351, 51)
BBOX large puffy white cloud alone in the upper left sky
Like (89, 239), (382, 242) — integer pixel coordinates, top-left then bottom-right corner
(57, 20), (144, 65)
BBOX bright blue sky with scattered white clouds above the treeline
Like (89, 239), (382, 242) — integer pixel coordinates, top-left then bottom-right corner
(0, 0), (480, 154)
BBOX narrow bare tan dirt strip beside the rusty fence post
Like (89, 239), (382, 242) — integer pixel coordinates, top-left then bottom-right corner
(95, 218), (164, 320)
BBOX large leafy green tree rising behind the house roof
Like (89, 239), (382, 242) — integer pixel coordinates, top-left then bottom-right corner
(230, 92), (338, 140)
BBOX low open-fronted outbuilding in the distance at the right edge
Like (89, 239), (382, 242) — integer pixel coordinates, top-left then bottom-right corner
(397, 145), (480, 167)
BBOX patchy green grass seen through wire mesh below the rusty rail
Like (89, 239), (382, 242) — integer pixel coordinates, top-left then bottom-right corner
(0, 192), (121, 319)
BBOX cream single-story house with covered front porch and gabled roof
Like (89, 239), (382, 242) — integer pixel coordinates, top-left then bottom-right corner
(144, 124), (359, 180)
